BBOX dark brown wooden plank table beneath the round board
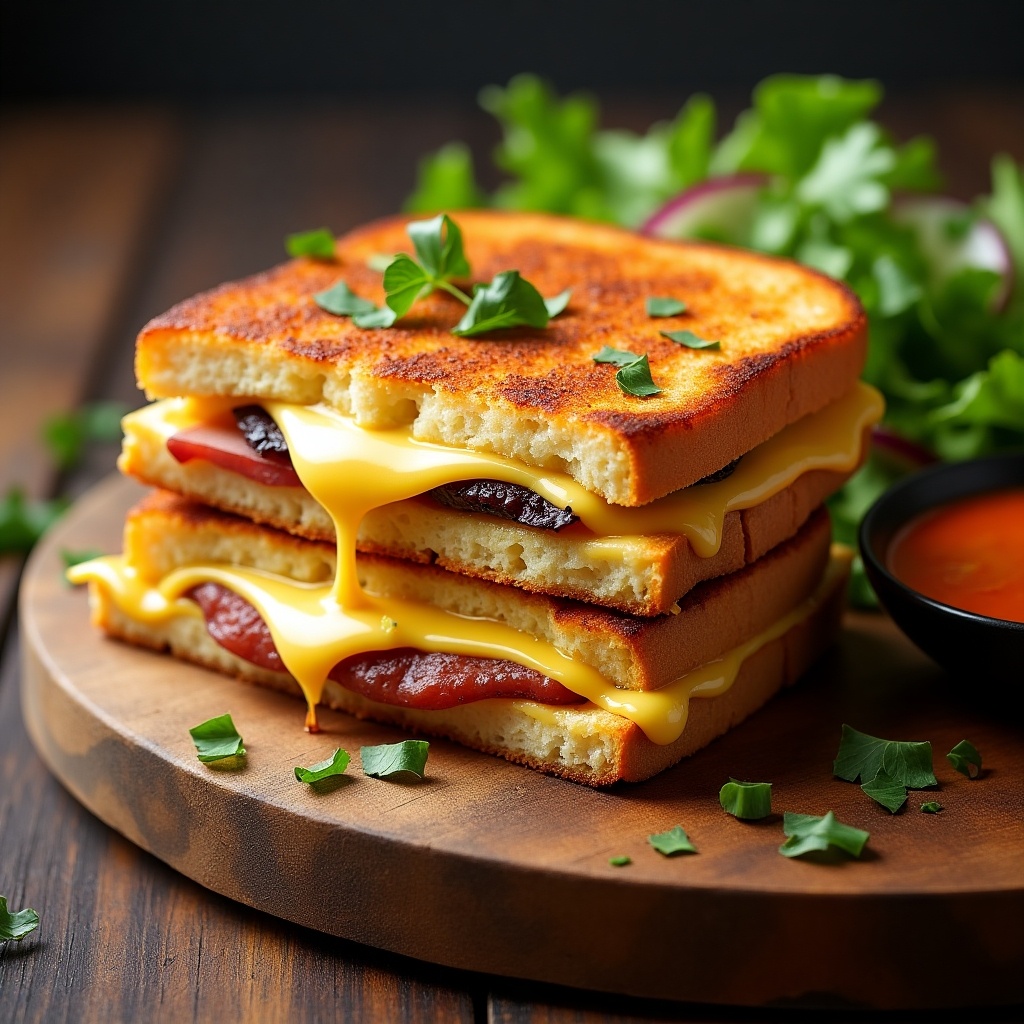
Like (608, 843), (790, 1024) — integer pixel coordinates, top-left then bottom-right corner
(0, 90), (1024, 1024)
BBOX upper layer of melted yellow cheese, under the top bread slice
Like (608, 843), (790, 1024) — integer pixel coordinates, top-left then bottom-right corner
(128, 383), (883, 593)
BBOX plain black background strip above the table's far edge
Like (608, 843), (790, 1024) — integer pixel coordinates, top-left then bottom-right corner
(0, 0), (1024, 99)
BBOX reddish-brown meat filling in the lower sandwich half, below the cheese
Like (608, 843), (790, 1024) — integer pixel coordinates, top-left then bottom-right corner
(186, 583), (585, 711)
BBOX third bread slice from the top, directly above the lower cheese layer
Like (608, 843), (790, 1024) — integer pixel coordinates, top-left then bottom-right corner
(117, 492), (830, 690)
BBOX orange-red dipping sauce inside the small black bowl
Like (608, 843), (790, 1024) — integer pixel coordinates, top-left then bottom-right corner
(886, 487), (1024, 623)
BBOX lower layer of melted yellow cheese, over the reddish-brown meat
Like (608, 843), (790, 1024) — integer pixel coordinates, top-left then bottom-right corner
(69, 546), (852, 743)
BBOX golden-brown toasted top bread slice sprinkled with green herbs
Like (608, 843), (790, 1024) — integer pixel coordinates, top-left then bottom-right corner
(136, 211), (866, 505)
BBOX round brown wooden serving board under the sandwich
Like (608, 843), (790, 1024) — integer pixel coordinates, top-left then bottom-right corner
(20, 479), (1024, 1008)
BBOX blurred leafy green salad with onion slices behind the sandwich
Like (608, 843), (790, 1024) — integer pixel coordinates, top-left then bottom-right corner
(407, 75), (1024, 603)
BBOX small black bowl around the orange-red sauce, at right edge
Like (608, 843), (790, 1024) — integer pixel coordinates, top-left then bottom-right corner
(860, 453), (1024, 689)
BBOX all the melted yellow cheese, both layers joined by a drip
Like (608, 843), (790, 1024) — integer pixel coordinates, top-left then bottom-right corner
(69, 384), (882, 743)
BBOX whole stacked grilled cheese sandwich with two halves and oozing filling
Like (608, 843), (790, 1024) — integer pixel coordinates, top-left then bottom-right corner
(73, 211), (881, 785)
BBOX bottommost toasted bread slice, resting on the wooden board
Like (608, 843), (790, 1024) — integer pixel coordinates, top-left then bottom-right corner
(90, 552), (846, 786)
